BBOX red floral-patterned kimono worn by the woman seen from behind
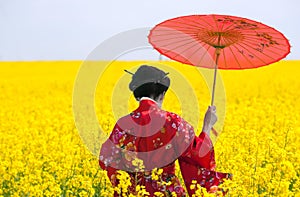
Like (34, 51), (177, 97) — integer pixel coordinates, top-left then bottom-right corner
(99, 98), (230, 196)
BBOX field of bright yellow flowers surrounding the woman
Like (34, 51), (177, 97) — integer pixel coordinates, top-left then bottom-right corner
(0, 61), (300, 197)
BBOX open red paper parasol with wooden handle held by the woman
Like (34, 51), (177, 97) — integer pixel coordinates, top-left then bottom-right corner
(148, 14), (290, 105)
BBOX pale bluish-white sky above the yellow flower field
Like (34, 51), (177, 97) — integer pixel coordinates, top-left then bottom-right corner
(0, 0), (300, 61)
